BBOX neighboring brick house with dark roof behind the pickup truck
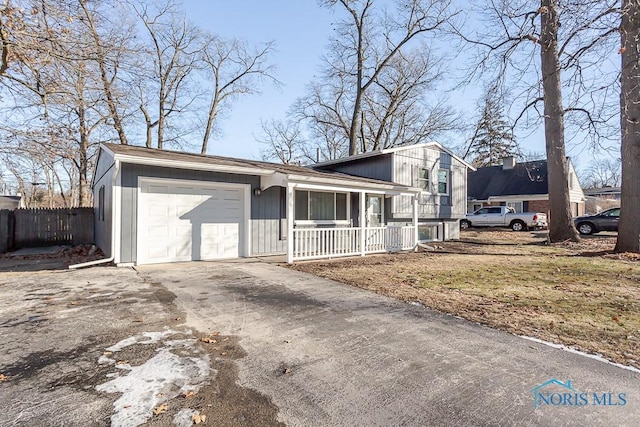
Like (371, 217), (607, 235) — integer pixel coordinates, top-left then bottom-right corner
(467, 157), (586, 219)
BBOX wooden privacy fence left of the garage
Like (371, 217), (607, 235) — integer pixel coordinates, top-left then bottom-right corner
(0, 208), (93, 252)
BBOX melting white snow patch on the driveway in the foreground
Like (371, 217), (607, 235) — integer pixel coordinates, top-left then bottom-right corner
(96, 331), (211, 427)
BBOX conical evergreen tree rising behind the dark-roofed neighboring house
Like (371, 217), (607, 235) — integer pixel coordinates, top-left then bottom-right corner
(464, 89), (517, 168)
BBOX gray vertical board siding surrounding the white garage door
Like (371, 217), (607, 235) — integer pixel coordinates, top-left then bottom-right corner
(120, 164), (286, 263)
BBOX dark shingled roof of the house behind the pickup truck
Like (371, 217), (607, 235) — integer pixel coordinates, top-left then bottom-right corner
(467, 160), (549, 200)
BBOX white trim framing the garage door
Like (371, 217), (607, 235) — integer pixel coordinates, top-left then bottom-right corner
(136, 176), (251, 264)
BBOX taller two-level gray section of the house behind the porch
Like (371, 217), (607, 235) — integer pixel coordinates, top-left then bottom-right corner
(312, 142), (475, 240)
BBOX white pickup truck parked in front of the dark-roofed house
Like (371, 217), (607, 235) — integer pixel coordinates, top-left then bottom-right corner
(460, 206), (547, 231)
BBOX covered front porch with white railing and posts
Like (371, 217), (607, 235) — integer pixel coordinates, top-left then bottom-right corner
(262, 174), (421, 263)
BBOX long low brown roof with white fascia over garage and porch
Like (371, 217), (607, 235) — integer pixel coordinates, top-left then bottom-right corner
(101, 143), (419, 192)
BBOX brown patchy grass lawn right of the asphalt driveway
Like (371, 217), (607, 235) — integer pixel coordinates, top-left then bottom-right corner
(291, 231), (640, 368)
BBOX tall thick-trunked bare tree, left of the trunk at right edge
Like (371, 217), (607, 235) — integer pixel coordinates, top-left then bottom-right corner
(462, 0), (617, 242)
